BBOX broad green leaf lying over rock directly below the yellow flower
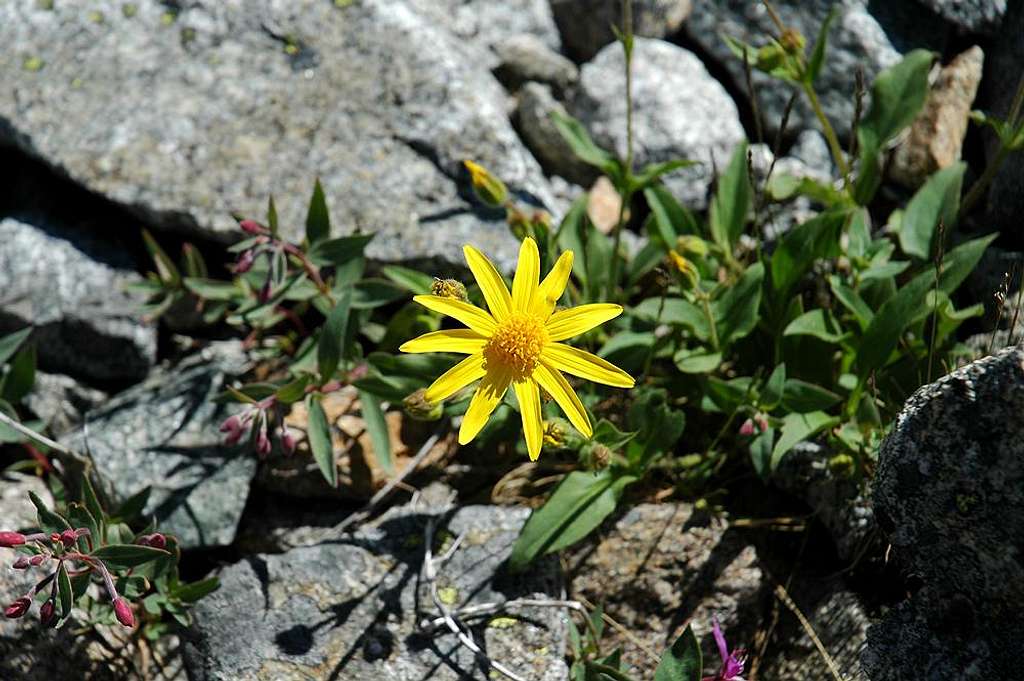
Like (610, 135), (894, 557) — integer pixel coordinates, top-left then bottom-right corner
(509, 469), (637, 572)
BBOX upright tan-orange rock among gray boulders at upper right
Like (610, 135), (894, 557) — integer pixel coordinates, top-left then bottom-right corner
(889, 45), (985, 188)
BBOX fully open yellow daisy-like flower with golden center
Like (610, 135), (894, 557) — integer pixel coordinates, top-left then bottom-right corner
(399, 239), (634, 460)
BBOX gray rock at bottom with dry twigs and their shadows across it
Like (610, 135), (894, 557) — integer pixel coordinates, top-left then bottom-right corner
(185, 506), (567, 681)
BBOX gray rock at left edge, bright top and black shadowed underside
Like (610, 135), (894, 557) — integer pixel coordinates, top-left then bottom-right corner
(0, 216), (157, 381)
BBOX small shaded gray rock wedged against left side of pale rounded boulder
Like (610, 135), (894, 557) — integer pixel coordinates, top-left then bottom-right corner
(515, 83), (600, 186)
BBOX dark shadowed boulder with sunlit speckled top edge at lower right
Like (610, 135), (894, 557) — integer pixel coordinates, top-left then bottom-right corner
(863, 348), (1024, 681)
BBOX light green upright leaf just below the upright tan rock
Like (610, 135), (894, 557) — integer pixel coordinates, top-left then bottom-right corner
(899, 161), (967, 260)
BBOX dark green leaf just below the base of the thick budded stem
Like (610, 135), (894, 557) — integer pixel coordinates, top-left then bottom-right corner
(771, 208), (849, 301)
